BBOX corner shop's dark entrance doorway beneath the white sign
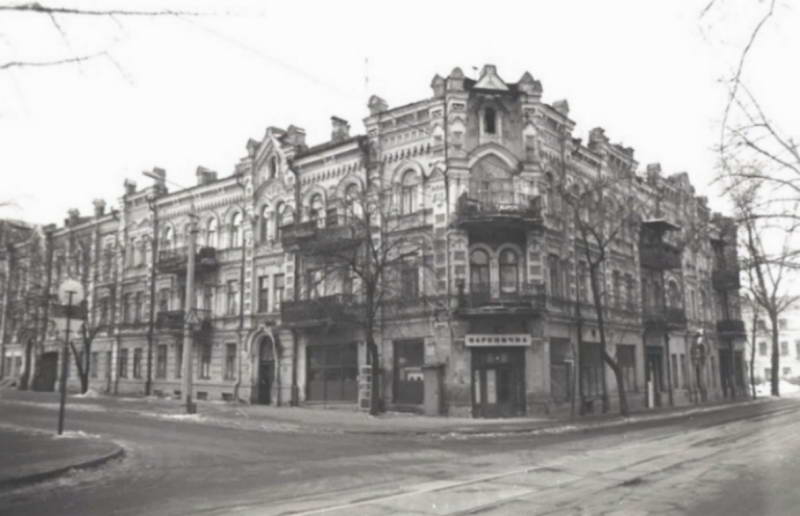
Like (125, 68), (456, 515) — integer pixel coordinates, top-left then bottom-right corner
(472, 348), (525, 417)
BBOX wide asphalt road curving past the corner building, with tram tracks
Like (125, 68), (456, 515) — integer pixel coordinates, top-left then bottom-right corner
(0, 394), (800, 516)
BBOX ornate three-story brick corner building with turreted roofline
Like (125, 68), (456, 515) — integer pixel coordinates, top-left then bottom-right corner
(3, 65), (744, 417)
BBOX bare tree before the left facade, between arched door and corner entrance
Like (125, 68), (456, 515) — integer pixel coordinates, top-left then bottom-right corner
(283, 141), (431, 414)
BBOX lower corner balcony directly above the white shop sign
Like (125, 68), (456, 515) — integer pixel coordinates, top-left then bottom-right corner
(456, 282), (546, 317)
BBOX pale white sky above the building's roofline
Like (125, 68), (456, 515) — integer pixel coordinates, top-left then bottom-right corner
(0, 0), (800, 223)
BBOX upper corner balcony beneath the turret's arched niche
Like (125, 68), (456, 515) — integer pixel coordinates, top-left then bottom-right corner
(453, 192), (542, 230)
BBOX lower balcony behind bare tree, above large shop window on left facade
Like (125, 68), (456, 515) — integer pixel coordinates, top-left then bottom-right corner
(281, 294), (358, 328)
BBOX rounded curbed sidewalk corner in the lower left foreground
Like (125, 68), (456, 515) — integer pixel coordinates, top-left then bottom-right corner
(0, 424), (124, 490)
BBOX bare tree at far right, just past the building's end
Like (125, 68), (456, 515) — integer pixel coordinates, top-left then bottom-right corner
(730, 175), (800, 396)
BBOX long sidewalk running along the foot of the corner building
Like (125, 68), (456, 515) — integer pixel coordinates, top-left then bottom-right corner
(0, 391), (771, 437)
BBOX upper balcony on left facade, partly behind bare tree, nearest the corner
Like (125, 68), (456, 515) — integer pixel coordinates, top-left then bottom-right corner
(281, 220), (364, 254)
